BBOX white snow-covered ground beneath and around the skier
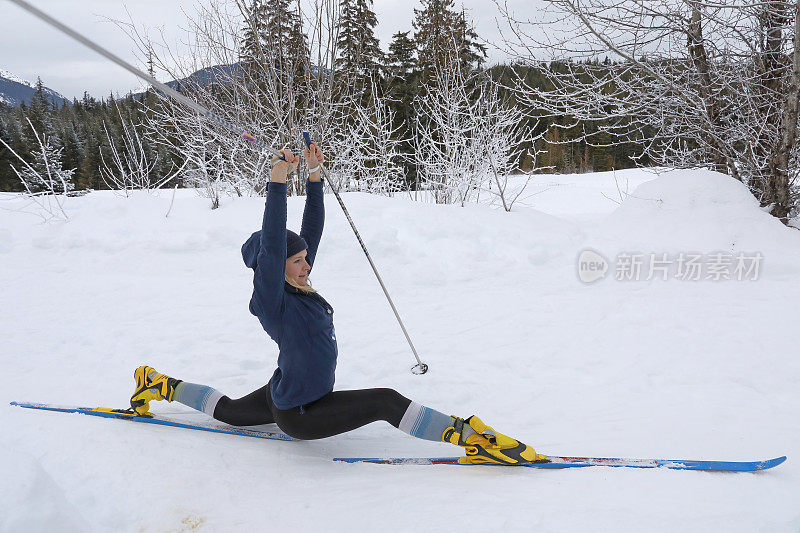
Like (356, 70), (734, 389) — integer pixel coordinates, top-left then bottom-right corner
(0, 170), (800, 532)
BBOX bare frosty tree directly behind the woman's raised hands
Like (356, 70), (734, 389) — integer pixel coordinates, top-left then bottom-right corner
(123, 0), (343, 202)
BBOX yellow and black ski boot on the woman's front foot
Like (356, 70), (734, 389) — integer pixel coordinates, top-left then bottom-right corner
(442, 415), (548, 466)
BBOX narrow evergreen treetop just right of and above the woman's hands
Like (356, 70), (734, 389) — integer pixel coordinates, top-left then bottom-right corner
(336, 0), (383, 80)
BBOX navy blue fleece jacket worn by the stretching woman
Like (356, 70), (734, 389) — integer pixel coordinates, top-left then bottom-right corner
(242, 181), (338, 409)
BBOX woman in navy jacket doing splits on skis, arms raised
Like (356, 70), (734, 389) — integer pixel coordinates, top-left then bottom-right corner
(131, 144), (545, 465)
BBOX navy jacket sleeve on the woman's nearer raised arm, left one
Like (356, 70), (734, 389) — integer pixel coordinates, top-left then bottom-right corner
(253, 181), (286, 318)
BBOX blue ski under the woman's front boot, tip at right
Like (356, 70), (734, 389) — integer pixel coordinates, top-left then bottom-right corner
(334, 456), (786, 472)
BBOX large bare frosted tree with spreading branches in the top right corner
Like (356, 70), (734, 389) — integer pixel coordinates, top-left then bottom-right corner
(496, 0), (800, 222)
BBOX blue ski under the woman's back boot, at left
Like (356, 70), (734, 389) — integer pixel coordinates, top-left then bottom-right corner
(11, 402), (295, 441)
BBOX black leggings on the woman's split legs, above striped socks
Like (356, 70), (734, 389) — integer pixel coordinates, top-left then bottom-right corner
(214, 383), (411, 440)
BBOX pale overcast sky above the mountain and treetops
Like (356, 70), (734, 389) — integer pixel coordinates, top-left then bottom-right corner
(0, 0), (539, 98)
